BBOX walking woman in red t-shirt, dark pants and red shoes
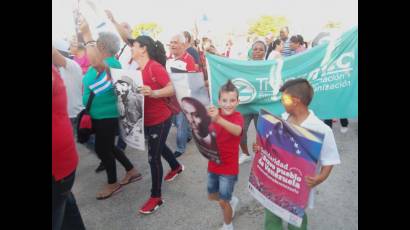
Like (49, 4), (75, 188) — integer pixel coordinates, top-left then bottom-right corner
(129, 35), (184, 214)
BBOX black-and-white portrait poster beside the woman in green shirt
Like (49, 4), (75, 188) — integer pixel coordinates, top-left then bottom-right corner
(110, 68), (145, 151)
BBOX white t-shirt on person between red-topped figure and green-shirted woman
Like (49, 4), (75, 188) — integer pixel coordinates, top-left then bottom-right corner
(59, 58), (84, 118)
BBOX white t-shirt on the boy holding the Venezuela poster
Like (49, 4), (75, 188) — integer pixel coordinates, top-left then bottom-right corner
(282, 110), (340, 208)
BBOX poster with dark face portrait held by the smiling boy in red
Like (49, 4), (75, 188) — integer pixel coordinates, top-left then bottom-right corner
(170, 73), (220, 163)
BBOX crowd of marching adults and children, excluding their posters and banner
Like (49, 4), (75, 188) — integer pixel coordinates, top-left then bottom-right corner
(52, 10), (348, 229)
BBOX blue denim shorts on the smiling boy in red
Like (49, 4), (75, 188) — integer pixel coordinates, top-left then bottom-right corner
(208, 172), (238, 201)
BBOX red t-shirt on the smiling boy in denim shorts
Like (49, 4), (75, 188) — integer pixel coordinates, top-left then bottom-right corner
(208, 109), (243, 175)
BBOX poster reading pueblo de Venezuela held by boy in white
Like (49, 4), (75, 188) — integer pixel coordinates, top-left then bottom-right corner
(248, 110), (324, 227)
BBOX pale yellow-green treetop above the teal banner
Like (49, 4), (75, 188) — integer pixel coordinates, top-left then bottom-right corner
(248, 15), (288, 36)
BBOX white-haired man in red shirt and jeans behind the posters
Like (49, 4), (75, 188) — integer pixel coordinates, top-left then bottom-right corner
(166, 33), (197, 157)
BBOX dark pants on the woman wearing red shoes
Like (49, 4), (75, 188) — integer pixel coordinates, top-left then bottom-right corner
(144, 118), (180, 197)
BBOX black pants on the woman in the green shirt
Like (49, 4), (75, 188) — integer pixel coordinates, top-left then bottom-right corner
(92, 118), (134, 184)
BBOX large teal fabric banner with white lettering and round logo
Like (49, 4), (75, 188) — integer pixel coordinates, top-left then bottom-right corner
(206, 27), (358, 119)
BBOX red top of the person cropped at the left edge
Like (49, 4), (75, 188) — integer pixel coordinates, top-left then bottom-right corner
(51, 66), (78, 181)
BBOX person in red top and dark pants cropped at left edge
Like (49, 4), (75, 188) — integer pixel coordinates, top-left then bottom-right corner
(51, 66), (85, 230)
